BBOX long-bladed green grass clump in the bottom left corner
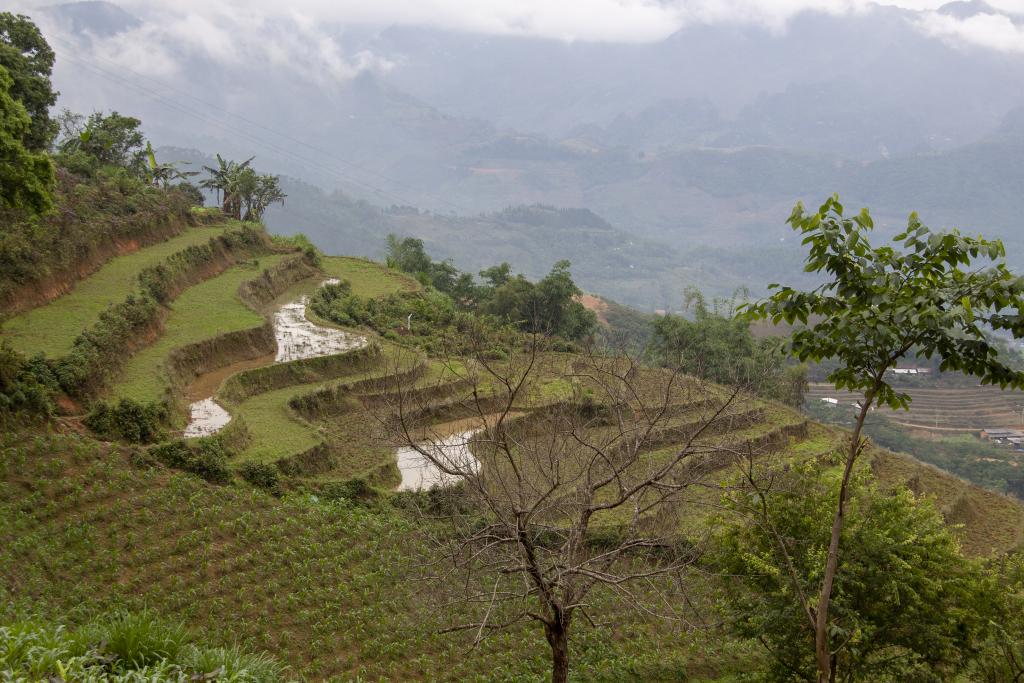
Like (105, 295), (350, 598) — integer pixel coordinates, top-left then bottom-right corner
(0, 611), (284, 683)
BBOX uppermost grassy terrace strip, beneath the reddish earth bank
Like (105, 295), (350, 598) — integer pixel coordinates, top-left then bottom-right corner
(0, 221), (237, 357)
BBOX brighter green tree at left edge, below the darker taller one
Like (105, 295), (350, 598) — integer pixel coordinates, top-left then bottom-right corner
(0, 67), (54, 213)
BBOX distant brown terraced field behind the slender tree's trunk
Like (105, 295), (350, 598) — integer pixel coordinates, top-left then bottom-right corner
(807, 384), (1024, 434)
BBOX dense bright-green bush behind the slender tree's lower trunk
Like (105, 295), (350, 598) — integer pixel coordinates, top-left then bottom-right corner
(716, 463), (987, 681)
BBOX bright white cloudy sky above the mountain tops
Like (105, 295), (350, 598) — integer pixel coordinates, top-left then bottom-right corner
(15, 0), (1024, 87)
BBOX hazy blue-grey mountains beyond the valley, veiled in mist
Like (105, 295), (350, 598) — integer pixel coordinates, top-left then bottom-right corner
(36, 2), (1024, 309)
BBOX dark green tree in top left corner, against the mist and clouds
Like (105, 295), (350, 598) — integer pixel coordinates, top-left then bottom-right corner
(0, 12), (57, 152)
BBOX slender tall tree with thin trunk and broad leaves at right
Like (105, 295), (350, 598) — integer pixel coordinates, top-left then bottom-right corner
(748, 196), (1024, 682)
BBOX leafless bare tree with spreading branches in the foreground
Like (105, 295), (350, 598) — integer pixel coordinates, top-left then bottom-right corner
(378, 336), (752, 683)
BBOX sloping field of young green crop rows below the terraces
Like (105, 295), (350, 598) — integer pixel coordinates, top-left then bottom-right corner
(0, 431), (708, 683)
